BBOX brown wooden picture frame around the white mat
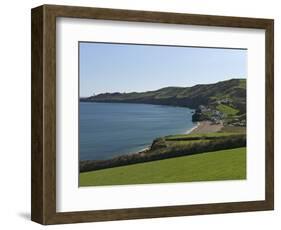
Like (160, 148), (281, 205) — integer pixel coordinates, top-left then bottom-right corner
(31, 5), (274, 224)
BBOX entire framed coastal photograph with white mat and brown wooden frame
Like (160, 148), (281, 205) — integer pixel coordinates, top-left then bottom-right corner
(31, 5), (274, 224)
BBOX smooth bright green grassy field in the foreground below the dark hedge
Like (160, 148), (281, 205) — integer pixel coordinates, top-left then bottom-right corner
(79, 147), (246, 186)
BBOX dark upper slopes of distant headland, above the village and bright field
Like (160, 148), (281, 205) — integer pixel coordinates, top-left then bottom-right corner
(80, 79), (246, 110)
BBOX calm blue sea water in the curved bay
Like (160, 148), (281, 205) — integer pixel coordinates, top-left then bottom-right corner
(79, 102), (196, 160)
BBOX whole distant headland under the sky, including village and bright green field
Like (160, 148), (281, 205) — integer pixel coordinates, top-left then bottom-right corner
(80, 79), (246, 127)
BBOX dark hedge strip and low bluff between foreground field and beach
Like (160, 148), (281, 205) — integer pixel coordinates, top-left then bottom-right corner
(79, 131), (246, 172)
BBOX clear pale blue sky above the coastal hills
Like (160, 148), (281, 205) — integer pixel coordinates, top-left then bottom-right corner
(79, 42), (247, 97)
